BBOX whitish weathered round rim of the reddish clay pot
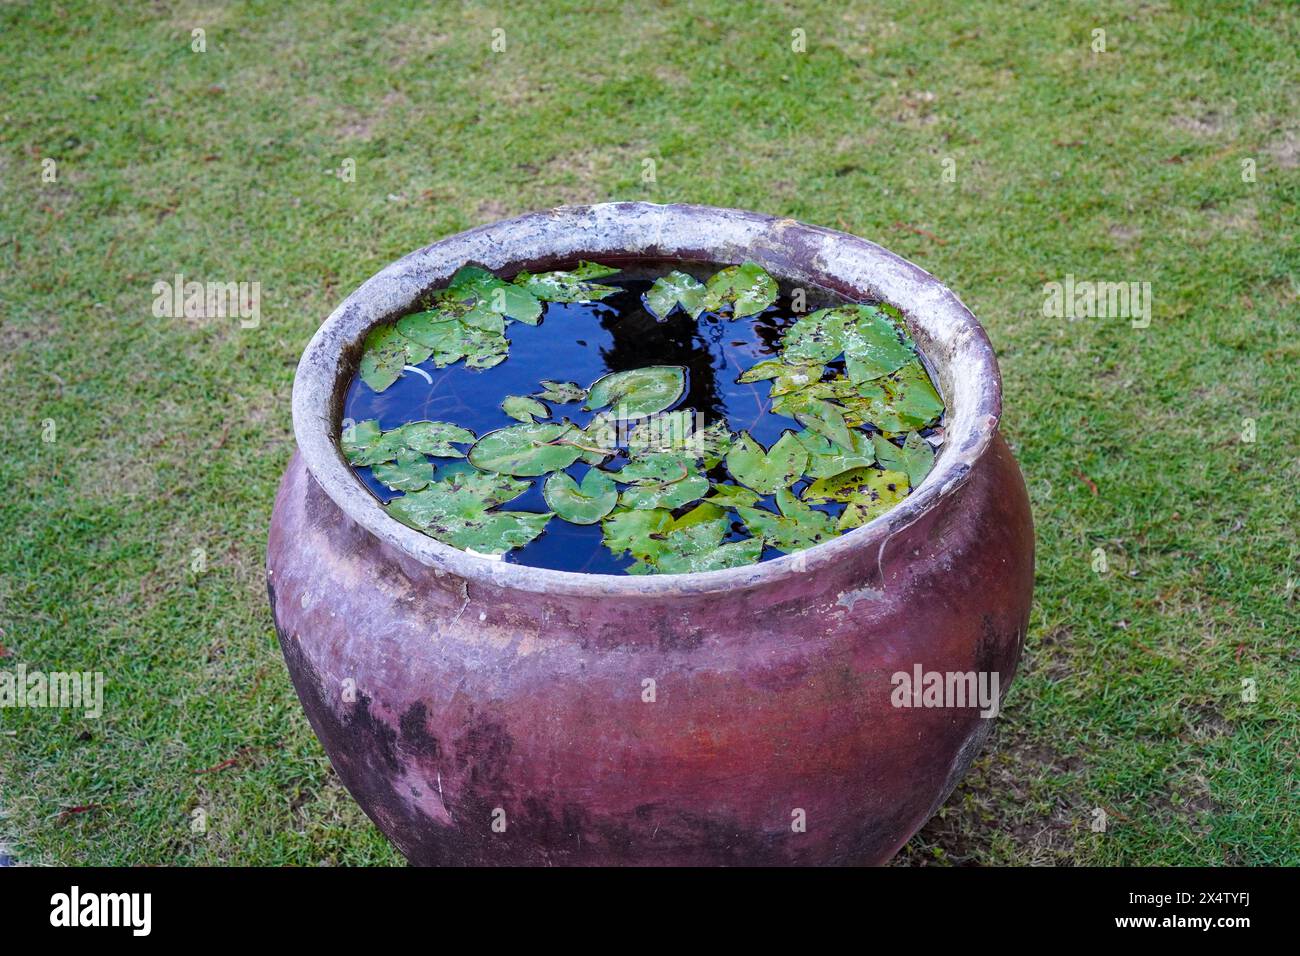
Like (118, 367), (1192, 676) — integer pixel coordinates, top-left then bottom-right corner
(293, 203), (1001, 597)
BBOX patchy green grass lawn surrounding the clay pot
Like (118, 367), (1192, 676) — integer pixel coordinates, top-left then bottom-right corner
(0, 0), (1300, 865)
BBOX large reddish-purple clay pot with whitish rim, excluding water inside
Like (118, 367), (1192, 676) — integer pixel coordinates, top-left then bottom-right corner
(267, 203), (1034, 864)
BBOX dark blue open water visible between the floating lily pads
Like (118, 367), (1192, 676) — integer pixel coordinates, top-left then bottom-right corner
(343, 273), (899, 574)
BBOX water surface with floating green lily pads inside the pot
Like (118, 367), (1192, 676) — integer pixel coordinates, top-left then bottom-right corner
(342, 261), (944, 574)
